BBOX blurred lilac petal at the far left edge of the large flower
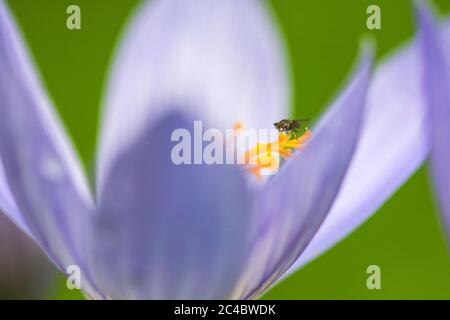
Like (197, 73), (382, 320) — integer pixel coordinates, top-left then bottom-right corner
(0, 1), (99, 298)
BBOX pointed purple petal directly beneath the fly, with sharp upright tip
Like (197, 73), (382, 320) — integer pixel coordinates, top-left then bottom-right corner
(232, 48), (372, 298)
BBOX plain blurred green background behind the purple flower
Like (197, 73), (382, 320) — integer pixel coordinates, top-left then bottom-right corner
(4, 0), (450, 299)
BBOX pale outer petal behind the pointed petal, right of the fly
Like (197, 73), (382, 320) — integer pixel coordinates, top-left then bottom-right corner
(286, 22), (442, 275)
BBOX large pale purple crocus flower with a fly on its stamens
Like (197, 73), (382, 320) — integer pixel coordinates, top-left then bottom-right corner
(0, 0), (428, 299)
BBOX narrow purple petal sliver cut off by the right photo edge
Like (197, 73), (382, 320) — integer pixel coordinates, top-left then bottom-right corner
(417, 4), (450, 240)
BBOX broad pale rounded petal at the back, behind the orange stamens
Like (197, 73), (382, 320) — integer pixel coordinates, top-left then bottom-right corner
(97, 0), (289, 195)
